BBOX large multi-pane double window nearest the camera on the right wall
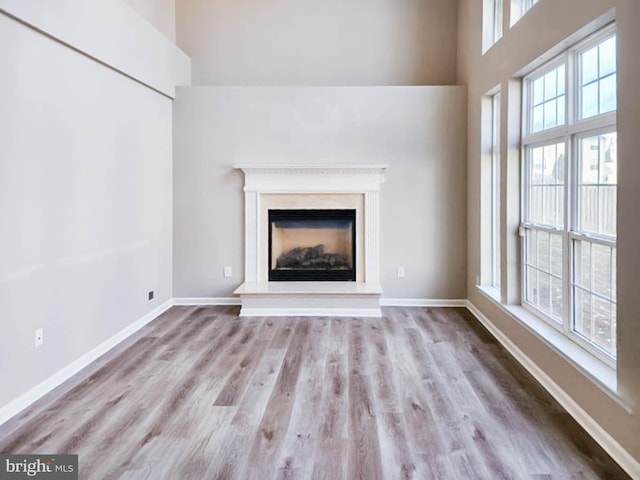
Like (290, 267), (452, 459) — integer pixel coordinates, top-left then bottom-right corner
(522, 27), (617, 358)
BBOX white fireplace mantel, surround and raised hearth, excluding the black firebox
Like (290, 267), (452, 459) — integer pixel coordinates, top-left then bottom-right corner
(234, 164), (387, 316)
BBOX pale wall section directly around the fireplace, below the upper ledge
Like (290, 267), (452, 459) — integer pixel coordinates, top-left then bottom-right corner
(174, 87), (466, 299)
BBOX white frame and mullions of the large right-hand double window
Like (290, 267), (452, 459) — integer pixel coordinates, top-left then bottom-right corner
(521, 25), (617, 367)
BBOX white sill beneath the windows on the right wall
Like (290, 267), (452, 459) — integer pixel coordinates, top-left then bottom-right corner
(476, 285), (632, 413)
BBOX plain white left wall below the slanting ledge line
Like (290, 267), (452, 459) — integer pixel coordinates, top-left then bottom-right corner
(0, 4), (180, 407)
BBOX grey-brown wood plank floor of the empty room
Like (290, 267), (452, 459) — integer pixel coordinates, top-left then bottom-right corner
(0, 307), (628, 480)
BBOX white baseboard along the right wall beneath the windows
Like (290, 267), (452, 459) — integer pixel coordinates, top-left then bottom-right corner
(466, 300), (640, 479)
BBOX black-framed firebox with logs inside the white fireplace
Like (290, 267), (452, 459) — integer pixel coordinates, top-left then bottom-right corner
(269, 209), (356, 281)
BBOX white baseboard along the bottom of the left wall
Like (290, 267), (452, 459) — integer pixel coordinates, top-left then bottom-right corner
(0, 300), (173, 425)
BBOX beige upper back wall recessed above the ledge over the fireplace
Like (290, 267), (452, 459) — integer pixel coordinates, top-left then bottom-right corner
(176, 0), (456, 85)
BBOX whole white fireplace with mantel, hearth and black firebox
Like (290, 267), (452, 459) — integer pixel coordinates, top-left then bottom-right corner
(234, 164), (387, 317)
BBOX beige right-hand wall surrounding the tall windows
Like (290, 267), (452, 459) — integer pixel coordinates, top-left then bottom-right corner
(458, 0), (640, 473)
